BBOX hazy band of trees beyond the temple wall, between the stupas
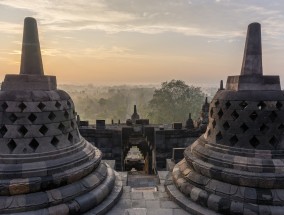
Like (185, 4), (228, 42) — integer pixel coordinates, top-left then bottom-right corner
(61, 80), (214, 124)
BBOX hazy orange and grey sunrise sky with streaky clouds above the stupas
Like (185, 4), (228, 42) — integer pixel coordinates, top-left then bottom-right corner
(0, 0), (284, 85)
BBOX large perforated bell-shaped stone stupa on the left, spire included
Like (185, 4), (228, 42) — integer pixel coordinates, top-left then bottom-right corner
(0, 18), (122, 215)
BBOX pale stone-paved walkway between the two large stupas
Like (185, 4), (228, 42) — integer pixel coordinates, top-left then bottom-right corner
(107, 171), (189, 215)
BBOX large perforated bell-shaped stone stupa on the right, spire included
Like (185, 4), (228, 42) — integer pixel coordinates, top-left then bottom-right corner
(167, 23), (284, 215)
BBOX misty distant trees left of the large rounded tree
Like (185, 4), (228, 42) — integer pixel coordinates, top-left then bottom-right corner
(61, 85), (155, 124)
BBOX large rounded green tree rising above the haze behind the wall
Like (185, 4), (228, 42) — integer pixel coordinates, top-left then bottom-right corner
(148, 80), (205, 124)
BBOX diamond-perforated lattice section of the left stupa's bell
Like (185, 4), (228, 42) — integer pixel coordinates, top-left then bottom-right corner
(0, 91), (80, 154)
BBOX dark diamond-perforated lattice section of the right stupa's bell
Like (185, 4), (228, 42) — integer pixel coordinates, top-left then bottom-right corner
(205, 95), (284, 150)
